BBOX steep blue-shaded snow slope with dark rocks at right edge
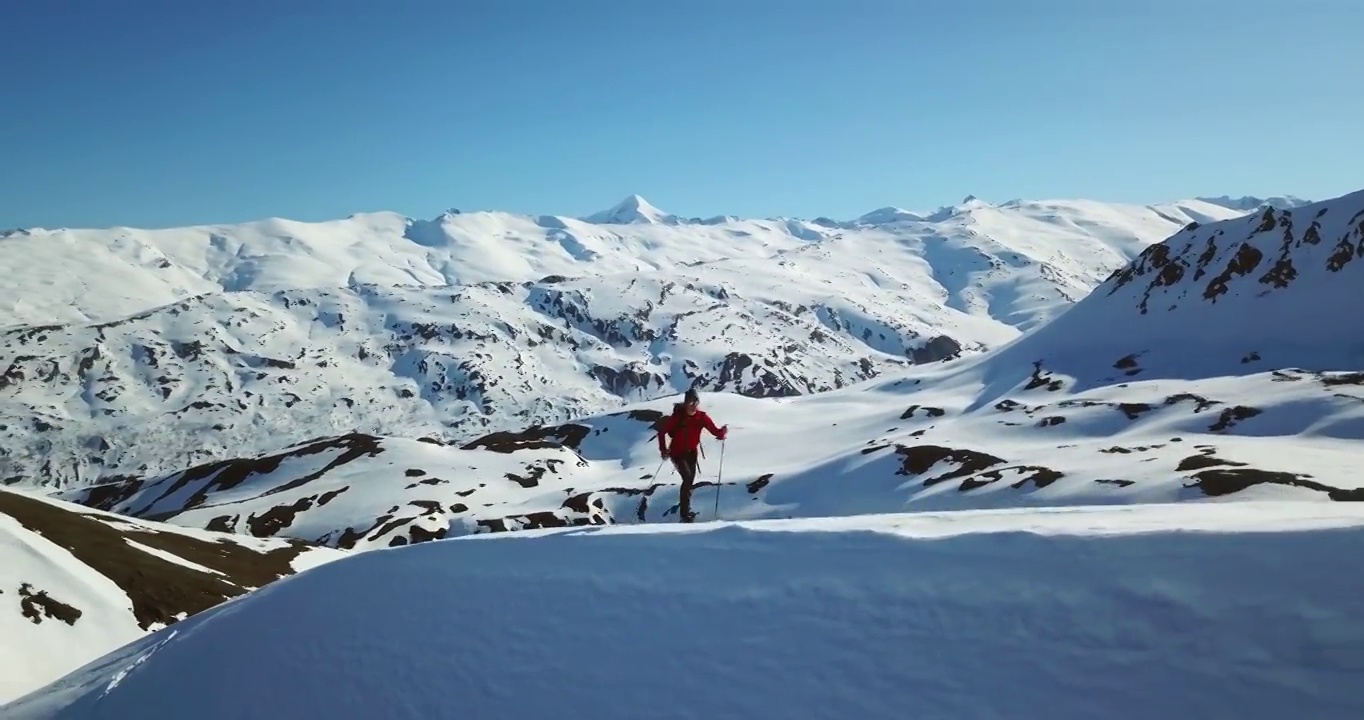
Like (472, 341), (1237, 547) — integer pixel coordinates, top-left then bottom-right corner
(989, 190), (1364, 386)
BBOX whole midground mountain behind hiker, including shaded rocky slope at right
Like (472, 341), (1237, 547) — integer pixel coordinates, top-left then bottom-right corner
(55, 191), (1364, 547)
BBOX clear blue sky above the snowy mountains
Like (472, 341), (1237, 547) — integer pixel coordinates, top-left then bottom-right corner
(0, 0), (1364, 228)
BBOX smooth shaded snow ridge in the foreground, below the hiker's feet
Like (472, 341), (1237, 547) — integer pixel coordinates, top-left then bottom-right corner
(8, 502), (1364, 720)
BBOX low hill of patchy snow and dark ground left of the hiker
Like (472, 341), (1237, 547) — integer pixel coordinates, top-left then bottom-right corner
(59, 430), (600, 550)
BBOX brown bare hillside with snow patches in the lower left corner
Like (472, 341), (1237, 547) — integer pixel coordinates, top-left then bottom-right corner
(0, 490), (341, 716)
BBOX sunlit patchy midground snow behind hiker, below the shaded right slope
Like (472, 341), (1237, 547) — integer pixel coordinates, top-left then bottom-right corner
(60, 361), (1364, 548)
